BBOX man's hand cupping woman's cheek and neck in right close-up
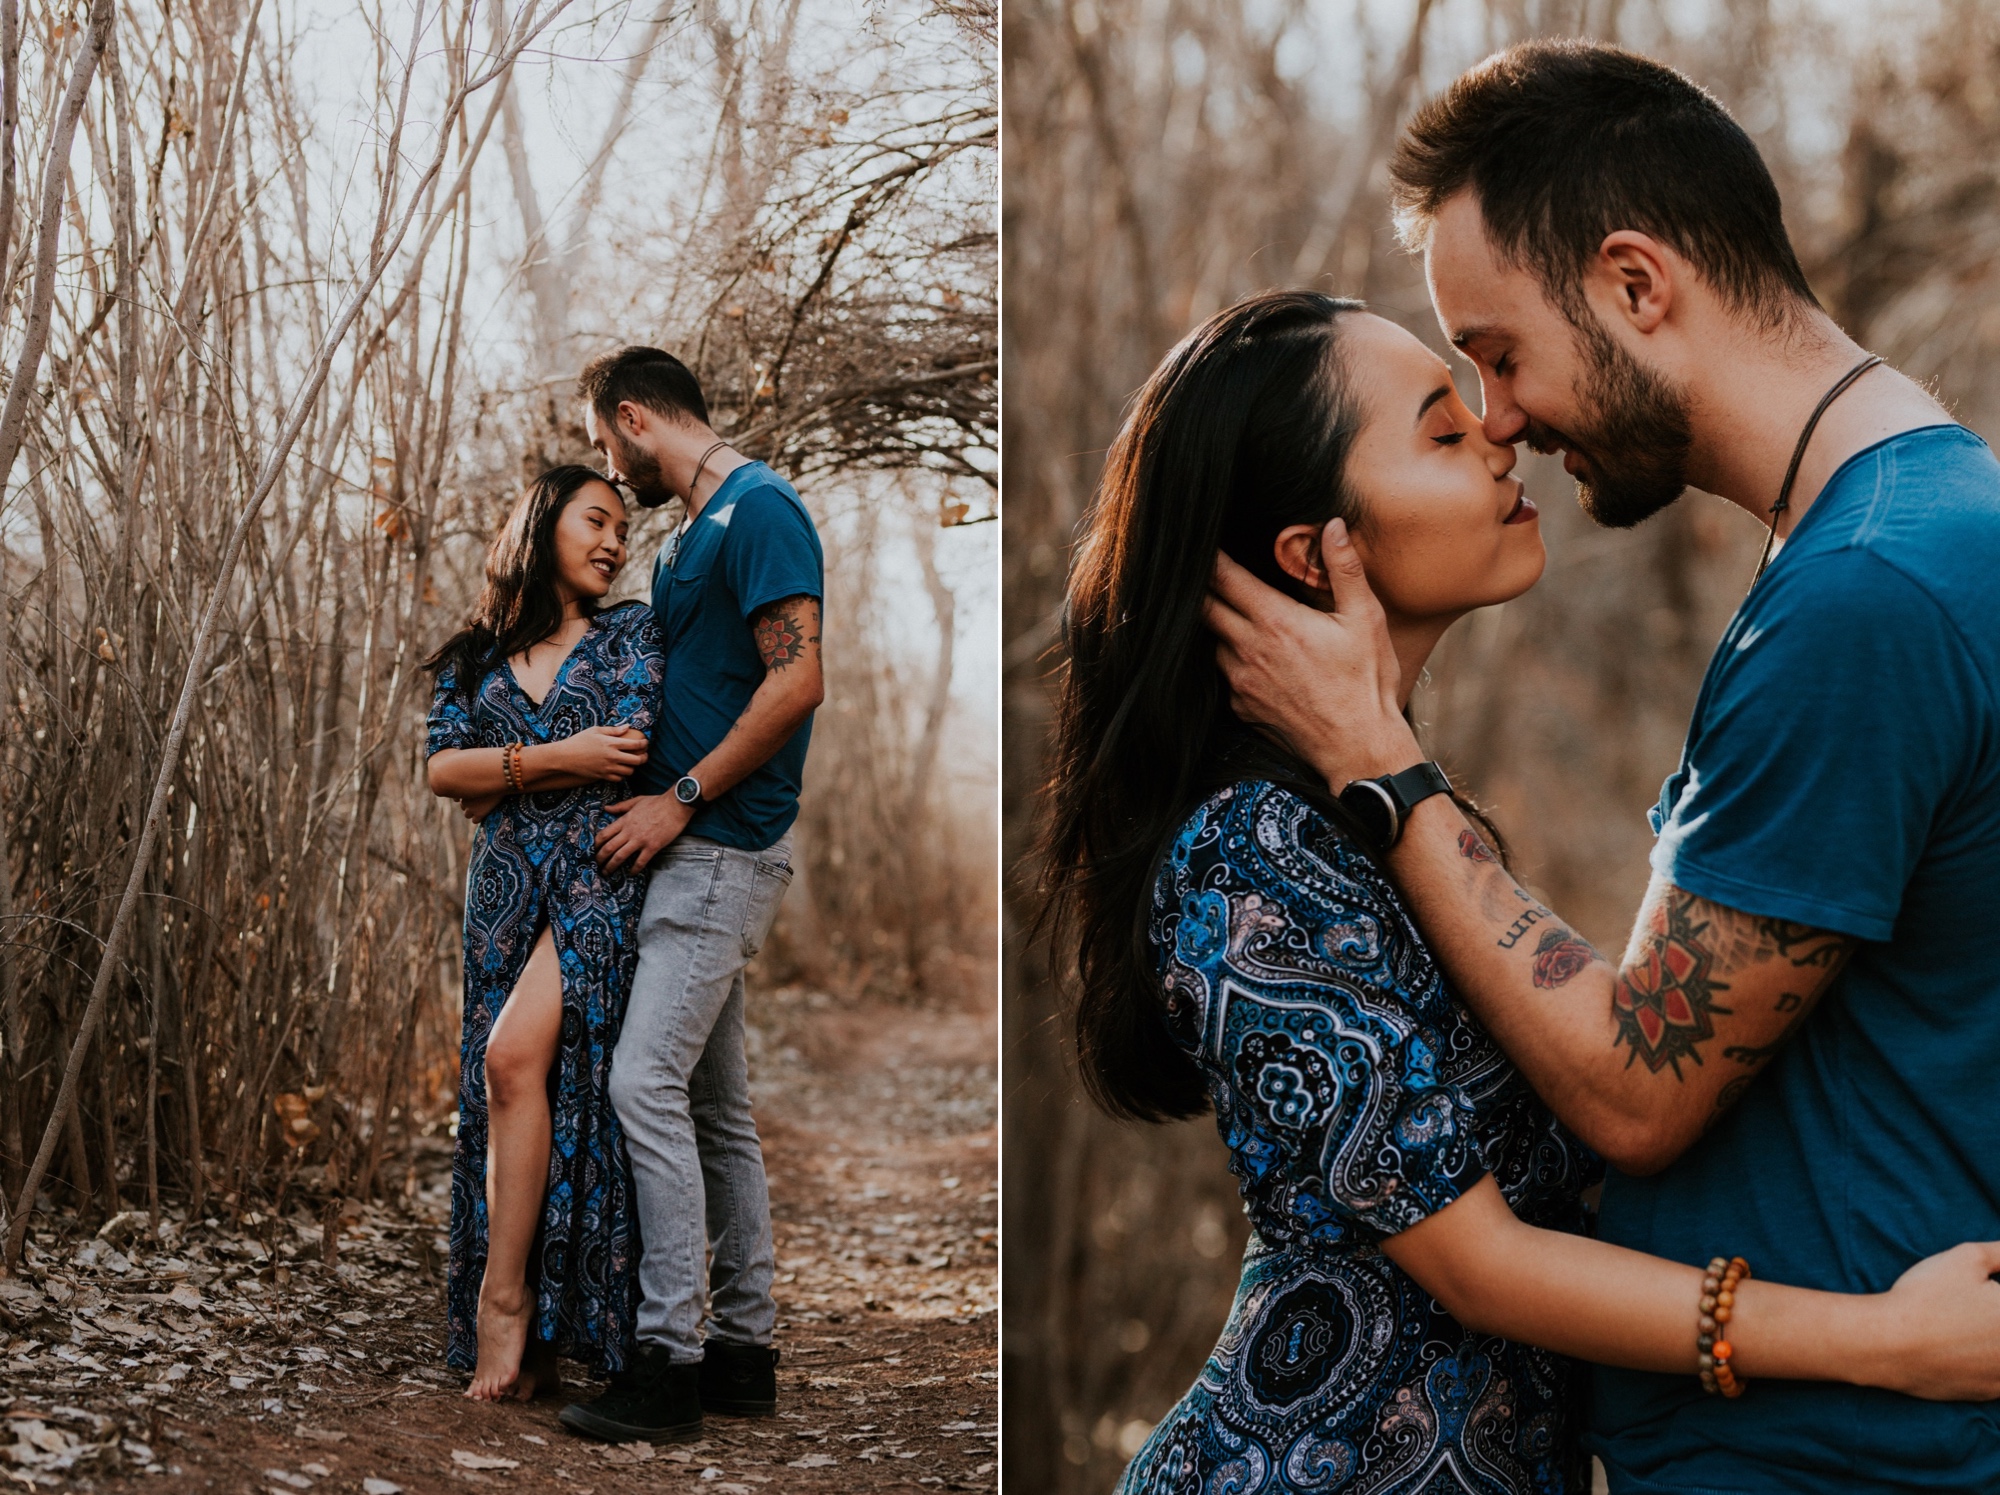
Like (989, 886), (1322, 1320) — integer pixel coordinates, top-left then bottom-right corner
(1206, 520), (1422, 789)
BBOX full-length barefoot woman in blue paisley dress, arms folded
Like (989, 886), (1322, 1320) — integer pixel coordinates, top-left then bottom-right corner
(428, 466), (664, 1401)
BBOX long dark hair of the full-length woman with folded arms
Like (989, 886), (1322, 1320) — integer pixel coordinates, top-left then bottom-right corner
(424, 464), (610, 696)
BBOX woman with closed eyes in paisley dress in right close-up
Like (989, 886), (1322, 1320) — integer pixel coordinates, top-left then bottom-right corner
(1044, 292), (1984, 1495)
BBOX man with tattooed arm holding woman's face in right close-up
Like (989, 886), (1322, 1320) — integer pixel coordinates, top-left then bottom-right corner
(1212, 42), (2000, 1495)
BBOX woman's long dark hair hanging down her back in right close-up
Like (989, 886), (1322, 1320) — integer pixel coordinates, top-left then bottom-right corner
(1042, 292), (1362, 1121)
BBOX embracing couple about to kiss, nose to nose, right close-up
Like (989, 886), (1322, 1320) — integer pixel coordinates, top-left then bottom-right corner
(1044, 42), (2000, 1495)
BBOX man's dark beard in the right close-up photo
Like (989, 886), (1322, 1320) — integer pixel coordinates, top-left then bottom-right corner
(1522, 312), (1694, 530)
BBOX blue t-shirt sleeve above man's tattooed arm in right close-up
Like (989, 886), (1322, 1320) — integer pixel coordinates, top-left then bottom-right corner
(1652, 550), (1988, 941)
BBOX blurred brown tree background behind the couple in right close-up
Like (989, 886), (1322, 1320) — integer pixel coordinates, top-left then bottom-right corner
(1002, 0), (2000, 1495)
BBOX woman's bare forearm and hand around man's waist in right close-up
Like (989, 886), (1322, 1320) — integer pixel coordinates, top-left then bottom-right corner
(1382, 1177), (2000, 1401)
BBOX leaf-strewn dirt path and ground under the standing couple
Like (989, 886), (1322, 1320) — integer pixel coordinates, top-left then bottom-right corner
(0, 989), (998, 1495)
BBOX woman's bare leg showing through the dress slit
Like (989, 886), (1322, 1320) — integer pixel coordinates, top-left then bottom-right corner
(466, 925), (562, 1401)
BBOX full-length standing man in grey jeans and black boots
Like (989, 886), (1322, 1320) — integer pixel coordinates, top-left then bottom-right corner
(562, 348), (824, 1443)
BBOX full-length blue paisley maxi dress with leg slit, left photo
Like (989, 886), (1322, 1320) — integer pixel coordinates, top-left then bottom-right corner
(428, 602), (666, 1371)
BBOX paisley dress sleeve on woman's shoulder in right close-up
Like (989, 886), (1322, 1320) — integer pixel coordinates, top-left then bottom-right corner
(1154, 785), (1488, 1237)
